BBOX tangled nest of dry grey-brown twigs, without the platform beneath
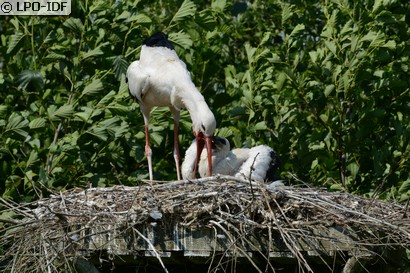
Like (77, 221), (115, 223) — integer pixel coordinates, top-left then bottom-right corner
(0, 176), (410, 273)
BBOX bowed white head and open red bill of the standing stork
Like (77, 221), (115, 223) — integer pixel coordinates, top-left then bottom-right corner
(192, 108), (216, 176)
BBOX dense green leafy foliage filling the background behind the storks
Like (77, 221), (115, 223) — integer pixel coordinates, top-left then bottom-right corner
(0, 0), (410, 200)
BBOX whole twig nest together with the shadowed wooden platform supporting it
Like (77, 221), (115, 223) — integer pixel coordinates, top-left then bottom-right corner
(0, 176), (410, 273)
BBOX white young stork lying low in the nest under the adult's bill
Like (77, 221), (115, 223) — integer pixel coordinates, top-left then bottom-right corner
(182, 136), (279, 181)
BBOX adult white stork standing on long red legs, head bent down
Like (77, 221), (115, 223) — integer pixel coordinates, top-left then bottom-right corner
(127, 32), (216, 180)
